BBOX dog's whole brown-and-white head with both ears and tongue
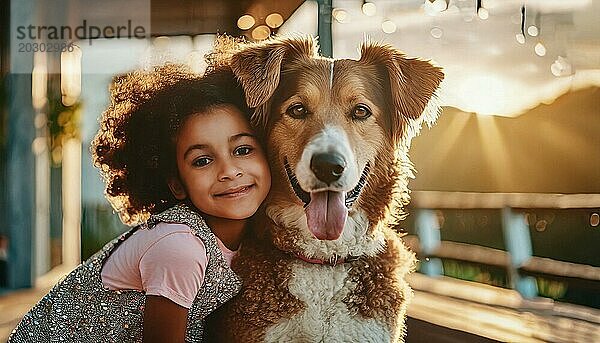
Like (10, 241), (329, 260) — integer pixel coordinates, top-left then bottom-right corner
(231, 38), (443, 255)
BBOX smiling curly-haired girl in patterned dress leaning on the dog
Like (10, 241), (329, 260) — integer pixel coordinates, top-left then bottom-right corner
(9, 65), (271, 342)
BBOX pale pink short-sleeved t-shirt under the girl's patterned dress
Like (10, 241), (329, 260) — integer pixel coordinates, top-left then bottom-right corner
(101, 223), (237, 308)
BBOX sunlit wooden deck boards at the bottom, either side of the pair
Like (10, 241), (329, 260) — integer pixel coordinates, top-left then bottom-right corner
(0, 269), (600, 343)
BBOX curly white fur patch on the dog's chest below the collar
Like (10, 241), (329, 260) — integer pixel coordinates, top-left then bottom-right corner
(265, 261), (391, 343)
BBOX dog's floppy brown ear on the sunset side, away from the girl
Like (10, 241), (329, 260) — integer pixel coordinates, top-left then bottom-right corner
(360, 43), (444, 142)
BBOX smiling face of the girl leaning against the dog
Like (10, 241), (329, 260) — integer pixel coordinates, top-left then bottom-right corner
(169, 105), (271, 219)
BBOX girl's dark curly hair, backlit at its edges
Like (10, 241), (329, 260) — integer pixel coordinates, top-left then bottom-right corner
(91, 64), (250, 225)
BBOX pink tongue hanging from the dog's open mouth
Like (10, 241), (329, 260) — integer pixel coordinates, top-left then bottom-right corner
(304, 191), (348, 240)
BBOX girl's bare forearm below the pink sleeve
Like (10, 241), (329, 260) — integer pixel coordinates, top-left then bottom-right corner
(143, 295), (188, 343)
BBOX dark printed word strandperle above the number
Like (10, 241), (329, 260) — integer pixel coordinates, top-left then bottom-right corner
(17, 19), (146, 45)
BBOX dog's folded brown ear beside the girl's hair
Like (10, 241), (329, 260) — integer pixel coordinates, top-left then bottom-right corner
(230, 36), (318, 125)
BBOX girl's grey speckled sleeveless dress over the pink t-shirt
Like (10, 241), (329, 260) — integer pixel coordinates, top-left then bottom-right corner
(8, 204), (242, 343)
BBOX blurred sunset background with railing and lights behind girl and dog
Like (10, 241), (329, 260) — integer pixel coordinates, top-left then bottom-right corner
(0, 0), (600, 342)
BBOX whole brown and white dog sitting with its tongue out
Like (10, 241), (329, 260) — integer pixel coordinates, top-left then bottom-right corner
(208, 37), (444, 342)
